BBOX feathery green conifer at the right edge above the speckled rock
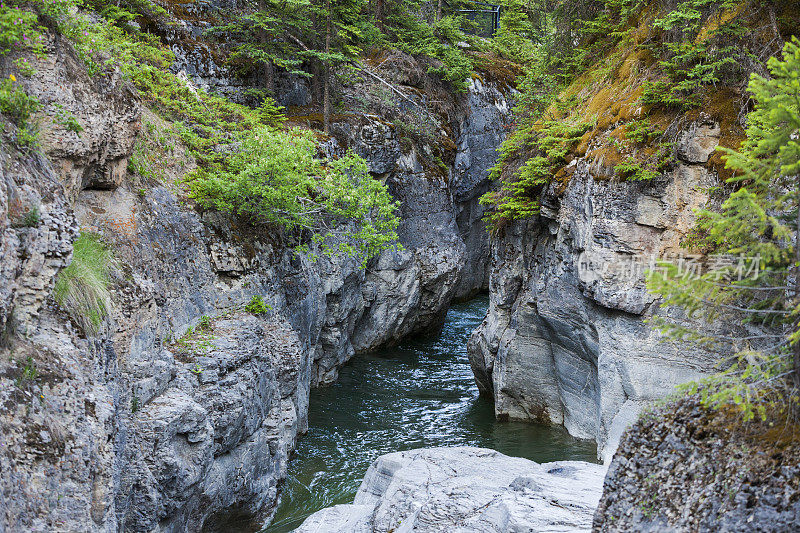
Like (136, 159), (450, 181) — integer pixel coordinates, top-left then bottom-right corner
(651, 39), (800, 418)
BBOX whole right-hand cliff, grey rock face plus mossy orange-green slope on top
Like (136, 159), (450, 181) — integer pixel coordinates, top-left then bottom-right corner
(462, 2), (793, 460)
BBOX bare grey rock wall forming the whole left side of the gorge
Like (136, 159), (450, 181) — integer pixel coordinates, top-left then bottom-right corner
(0, 26), (507, 531)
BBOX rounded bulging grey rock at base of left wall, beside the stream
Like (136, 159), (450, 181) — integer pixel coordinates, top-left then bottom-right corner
(117, 313), (310, 531)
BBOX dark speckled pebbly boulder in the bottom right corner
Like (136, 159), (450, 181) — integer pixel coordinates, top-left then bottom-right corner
(594, 397), (800, 532)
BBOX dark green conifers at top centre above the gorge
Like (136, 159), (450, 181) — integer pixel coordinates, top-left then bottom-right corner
(209, 0), (485, 133)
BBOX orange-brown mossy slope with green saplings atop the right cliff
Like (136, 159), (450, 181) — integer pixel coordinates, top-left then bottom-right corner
(483, 0), (796, 229)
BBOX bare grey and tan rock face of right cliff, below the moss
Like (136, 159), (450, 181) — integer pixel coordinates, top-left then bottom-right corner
(468, 121), (719, 459)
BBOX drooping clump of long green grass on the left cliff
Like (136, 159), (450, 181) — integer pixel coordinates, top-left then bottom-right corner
(53, 233), (119, 335)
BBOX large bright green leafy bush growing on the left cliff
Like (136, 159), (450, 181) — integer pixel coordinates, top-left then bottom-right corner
(189, 127), (399, 263)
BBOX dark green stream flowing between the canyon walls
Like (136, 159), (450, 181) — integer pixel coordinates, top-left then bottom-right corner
(263, 296), (596, 533)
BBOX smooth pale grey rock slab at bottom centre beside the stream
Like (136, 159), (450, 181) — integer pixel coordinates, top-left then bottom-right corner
(296, 447), (605, 533)
